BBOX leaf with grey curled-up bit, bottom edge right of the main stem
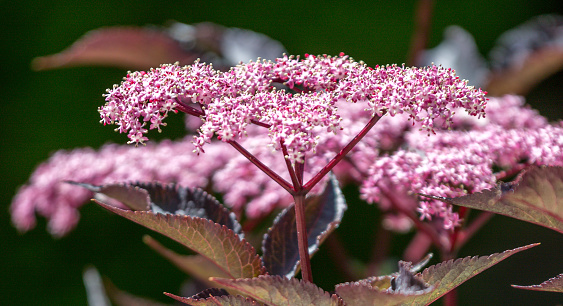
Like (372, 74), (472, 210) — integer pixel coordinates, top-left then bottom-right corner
(336, 261), (435, 305)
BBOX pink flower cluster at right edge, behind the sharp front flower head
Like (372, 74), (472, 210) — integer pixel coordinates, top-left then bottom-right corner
(361, 96), (563, 229)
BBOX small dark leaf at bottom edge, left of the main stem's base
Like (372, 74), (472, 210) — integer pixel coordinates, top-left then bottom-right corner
(164, 288), (260, 306)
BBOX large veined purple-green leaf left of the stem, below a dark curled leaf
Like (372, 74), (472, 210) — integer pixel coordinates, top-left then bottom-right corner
(96, 201), (265, 278)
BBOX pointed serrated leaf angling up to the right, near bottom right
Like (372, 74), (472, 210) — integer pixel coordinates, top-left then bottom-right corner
(408, 243), (539, 305)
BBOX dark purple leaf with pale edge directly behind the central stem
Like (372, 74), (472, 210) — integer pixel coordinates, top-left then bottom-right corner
(262, 175), (347, 278)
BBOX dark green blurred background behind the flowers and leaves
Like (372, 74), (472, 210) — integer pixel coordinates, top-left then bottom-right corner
(0, 0), (563, 305)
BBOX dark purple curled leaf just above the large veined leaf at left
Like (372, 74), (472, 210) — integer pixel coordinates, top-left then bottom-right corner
(75, 182), (242, 237)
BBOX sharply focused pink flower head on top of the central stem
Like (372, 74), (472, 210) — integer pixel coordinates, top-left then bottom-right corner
(99, 54), (486, 163)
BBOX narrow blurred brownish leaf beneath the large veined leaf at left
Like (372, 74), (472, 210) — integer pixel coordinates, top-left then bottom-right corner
(143, 235), (229, 287)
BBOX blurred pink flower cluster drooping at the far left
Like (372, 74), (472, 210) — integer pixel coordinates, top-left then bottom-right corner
(11, 139), (237, 236)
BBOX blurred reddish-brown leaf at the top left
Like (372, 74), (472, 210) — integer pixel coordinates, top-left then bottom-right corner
(32, 27), (198, 70)
